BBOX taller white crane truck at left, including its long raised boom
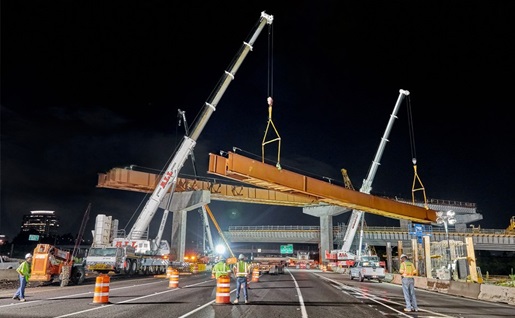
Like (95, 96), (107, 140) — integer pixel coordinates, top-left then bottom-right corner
(86, 11), (273, 274)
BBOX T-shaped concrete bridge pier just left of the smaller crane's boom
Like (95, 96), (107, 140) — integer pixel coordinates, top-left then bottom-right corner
(302, 205), (351, 262)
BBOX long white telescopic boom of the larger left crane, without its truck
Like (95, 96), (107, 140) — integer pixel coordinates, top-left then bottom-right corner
(128, 11), (273, 239)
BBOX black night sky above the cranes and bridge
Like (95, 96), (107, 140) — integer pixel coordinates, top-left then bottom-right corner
(0, 1), (515, 245)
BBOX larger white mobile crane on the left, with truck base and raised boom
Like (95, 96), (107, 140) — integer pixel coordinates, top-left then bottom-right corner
(86, 11), (273, 274)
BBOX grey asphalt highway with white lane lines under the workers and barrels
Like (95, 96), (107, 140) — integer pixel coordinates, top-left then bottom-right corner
(0, 268), (515, 318)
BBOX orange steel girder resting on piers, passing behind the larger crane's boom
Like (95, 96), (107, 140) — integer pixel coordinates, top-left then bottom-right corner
(97, 168), (318, 207)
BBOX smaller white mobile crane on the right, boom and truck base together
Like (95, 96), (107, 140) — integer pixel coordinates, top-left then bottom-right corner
(325, 89), (409, 267)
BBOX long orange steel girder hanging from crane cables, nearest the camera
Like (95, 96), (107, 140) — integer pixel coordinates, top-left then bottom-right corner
(208, 152), (436, 224)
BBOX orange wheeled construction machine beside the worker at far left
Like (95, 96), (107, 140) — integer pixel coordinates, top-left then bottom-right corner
(29, 244), (86, 287)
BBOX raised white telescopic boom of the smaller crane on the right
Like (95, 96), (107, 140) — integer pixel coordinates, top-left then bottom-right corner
(341, 89), (409, 253)
